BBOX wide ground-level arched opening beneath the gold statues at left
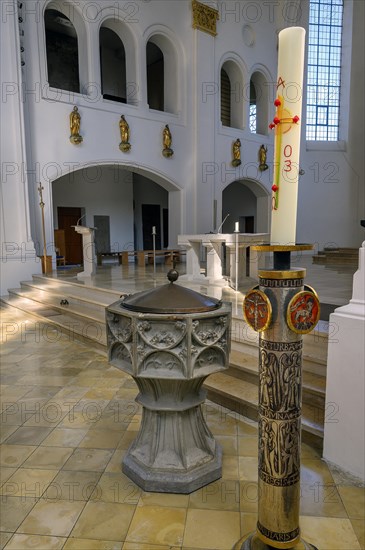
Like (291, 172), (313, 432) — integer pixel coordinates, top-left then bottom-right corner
(52, 164), (180, 264)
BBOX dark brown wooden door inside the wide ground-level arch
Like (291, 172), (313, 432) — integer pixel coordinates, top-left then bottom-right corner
(57, 206), (82, 265)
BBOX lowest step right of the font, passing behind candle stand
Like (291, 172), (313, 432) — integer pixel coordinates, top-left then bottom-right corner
(204, 373), (325, 450)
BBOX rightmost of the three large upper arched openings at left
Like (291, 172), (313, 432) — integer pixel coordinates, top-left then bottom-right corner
(146, 34), (179, 113)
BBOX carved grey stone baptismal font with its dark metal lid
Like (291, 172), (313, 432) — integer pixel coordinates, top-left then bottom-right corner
(106, 270), (231, 493)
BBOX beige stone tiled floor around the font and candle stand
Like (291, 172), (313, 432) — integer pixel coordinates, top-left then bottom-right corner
(0, 280), (365, 550)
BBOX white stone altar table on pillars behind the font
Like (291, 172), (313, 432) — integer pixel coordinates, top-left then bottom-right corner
(177, 233), (270, 286)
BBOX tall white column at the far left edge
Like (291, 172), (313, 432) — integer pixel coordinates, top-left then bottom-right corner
(0, 0), (41, 294)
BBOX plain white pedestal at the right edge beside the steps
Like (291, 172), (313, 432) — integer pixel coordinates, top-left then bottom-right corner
(323, 242), (365, 480)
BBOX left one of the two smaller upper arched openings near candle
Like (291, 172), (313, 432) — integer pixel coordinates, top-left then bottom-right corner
(220, 59), (245, 129)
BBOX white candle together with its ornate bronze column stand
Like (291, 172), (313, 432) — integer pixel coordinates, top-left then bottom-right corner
(235, 28), (320, 550)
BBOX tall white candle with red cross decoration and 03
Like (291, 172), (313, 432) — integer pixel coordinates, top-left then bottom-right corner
(270, 27), (305, 245)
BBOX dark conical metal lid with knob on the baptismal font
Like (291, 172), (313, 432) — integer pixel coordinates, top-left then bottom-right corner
(121, 269), (222, 313)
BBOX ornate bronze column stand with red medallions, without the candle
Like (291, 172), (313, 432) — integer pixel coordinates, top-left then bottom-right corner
(235, 244), (319, 550)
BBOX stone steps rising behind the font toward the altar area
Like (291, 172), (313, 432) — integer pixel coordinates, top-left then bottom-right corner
(1, 275), (328, 448)
